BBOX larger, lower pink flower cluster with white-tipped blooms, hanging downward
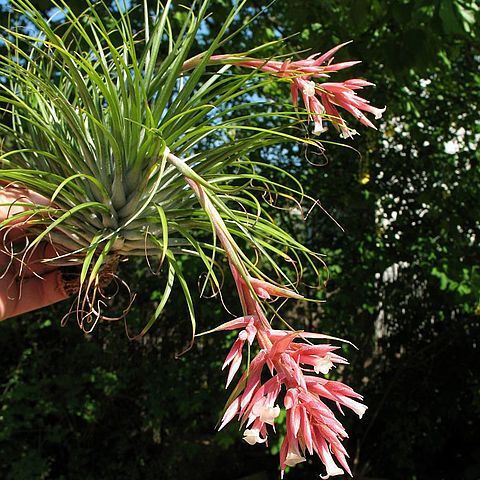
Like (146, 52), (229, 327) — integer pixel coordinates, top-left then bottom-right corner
(215, 265), (367, 479)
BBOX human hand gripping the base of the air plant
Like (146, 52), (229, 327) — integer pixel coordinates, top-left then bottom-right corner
(0, 185), (77, 320)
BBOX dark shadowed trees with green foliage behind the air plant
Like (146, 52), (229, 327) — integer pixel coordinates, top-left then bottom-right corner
(0, 0), (480, 480)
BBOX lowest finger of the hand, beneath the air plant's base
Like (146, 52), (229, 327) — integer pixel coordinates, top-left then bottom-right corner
(0, 270), (69, 320)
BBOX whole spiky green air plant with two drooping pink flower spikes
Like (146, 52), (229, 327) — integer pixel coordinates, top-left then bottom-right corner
(0, 0), (383, 478)
